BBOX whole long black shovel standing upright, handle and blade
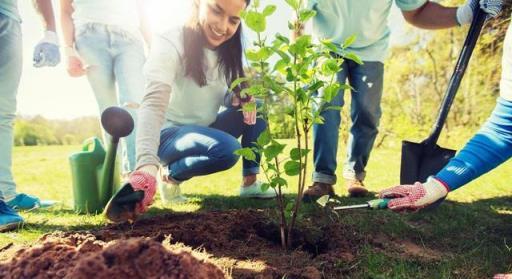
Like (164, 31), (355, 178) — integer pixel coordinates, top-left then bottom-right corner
(400, 8), (487, 184)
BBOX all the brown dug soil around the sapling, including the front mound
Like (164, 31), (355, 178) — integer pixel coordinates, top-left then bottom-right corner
(0, 210), (440, 279)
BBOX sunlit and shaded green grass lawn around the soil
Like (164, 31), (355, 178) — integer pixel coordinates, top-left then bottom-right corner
(0, 143), (512, 278)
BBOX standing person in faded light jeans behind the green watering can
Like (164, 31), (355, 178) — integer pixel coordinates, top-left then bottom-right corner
(61, 0), (150, 175)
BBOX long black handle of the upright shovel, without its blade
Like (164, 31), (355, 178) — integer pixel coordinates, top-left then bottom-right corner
(425, 8), (487, 145)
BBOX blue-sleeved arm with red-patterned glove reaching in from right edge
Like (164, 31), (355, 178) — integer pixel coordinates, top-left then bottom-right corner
(380, 19), (512, 279)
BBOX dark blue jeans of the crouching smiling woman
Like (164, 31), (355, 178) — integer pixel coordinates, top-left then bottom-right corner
(158, 105), (267, 181)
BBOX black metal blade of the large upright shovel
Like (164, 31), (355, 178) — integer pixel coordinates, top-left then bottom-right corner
(400, 141), (456, 184)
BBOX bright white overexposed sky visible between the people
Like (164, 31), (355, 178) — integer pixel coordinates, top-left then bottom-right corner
(17, 0), (403, 119)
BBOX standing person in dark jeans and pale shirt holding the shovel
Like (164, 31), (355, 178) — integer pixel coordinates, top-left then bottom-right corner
(302, 0), (502, 201)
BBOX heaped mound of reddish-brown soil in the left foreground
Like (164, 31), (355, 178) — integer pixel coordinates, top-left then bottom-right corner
(0, 234), (225, 279)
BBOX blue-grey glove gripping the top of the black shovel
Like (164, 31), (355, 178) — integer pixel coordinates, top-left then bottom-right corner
(457, 0), (503, 25)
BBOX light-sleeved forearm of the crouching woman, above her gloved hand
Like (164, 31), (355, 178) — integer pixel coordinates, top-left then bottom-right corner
(136, 81), (171, 169)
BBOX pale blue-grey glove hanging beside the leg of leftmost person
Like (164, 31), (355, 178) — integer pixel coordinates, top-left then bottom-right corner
(33, 31), (60, 68)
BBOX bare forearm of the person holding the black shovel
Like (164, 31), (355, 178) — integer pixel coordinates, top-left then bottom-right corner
(402, 1), (458, 29)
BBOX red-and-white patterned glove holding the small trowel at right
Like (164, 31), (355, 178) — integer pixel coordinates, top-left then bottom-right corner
(379, 177), (449, 212)
